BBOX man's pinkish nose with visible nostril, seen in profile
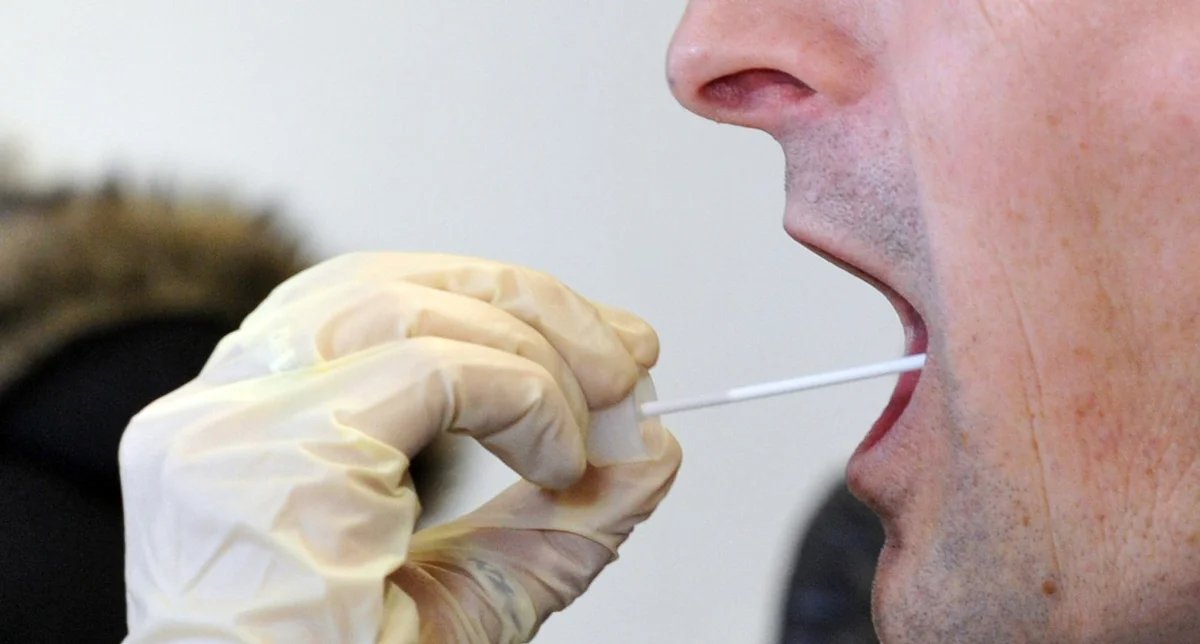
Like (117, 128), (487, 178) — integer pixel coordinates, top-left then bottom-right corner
(667, 0), (869, 134)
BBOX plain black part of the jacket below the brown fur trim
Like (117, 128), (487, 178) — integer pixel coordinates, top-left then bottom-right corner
(0, 318), (232, 644)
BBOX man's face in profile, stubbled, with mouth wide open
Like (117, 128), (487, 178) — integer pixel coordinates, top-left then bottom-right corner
(670, 0), (1200, 642)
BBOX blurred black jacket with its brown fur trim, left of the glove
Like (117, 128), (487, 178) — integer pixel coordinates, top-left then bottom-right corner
(0, 189), (301, 644)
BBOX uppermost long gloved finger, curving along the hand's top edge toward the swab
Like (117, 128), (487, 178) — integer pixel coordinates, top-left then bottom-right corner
(268, 253), (638, 409)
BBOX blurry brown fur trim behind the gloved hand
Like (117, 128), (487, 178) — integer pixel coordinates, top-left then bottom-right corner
(0, 187), (306, 391)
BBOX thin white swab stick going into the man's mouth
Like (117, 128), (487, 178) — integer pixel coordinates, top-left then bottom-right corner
(641, 354), (925, 416)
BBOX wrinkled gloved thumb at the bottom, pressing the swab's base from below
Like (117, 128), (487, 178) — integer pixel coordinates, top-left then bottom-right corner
(390, 426), (680, 642)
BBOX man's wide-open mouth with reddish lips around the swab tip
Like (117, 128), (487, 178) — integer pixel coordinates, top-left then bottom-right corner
(802, 242), (929, 455)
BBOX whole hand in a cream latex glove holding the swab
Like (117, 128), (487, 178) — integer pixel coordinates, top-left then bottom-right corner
(120, 254), (680, 644)
